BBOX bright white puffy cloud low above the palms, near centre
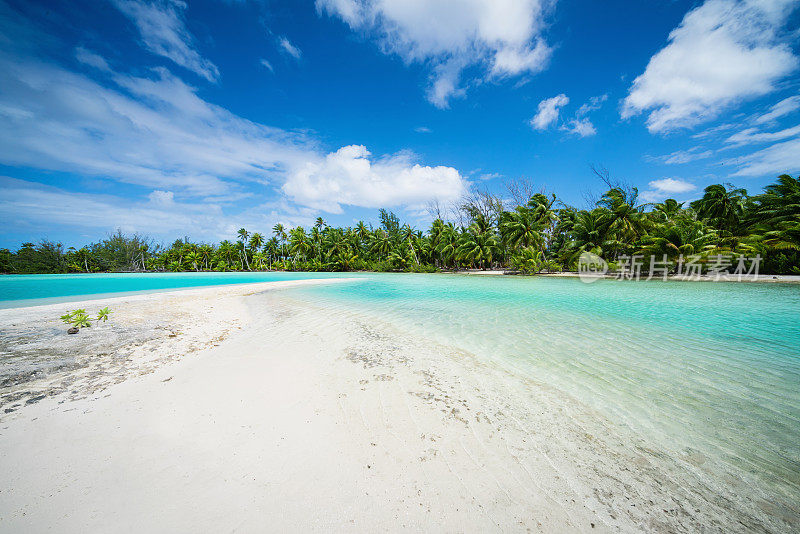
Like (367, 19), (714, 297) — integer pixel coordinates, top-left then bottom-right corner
(283, 145), (466, 213)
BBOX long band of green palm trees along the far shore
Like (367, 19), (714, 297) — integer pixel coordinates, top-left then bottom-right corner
(0, 176), (800, 274)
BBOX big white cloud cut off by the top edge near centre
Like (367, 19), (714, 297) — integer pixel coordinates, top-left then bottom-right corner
(316, 0), (552, 108)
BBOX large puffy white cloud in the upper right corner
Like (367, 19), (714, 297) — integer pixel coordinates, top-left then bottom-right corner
(622, 0), (798, 132)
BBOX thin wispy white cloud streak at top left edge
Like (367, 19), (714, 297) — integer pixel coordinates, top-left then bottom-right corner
(112, 0), (219, 82)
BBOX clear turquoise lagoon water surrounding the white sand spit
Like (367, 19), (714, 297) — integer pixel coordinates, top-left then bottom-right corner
(0, 273), (800, 508)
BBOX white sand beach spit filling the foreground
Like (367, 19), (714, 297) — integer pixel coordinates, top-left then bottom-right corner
(0, 280), (794, 532)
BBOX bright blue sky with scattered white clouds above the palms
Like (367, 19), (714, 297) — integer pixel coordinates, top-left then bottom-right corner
(0, 0), (800, 247)
